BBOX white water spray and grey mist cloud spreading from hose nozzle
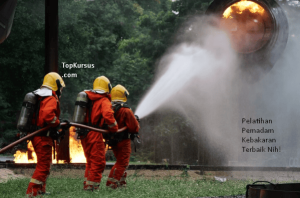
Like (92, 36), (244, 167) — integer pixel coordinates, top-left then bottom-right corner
(136, 3), (300, 167)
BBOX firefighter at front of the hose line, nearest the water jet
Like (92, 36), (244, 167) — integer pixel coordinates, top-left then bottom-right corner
(104, 85), (140, 189)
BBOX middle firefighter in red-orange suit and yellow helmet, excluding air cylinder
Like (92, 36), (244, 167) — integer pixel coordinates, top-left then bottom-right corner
(80, 76), (118, 191)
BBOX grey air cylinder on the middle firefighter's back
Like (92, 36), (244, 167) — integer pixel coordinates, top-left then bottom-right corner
(73, 91), (89, 124)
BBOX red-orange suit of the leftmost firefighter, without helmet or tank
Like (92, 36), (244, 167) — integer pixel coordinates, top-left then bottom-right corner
(26, 91), (60, 197)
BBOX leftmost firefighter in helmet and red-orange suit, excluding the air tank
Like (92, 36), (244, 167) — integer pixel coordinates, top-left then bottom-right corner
(26, 72), (65, 197)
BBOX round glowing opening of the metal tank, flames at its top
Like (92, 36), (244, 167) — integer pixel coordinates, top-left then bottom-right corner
(220, 0), (273, 54)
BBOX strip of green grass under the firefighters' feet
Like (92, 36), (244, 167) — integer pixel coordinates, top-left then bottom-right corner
(0, 176), (248, 198)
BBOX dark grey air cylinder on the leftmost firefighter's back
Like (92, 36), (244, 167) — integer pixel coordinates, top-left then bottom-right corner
(17, 92), (37, 132)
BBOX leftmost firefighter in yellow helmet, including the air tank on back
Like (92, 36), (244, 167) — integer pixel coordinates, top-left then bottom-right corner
(22, 72), (65, 197)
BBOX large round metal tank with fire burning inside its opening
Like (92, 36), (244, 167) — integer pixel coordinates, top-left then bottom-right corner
(206, 0), (288, 72)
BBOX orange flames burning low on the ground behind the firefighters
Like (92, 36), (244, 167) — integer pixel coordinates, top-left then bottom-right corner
(14, 127), (86, 164)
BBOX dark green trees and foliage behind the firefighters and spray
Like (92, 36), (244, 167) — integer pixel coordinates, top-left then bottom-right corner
(0, 0), (296, 164)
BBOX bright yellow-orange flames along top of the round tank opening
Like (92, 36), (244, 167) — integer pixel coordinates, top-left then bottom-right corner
(223, 0), (265, 19)
